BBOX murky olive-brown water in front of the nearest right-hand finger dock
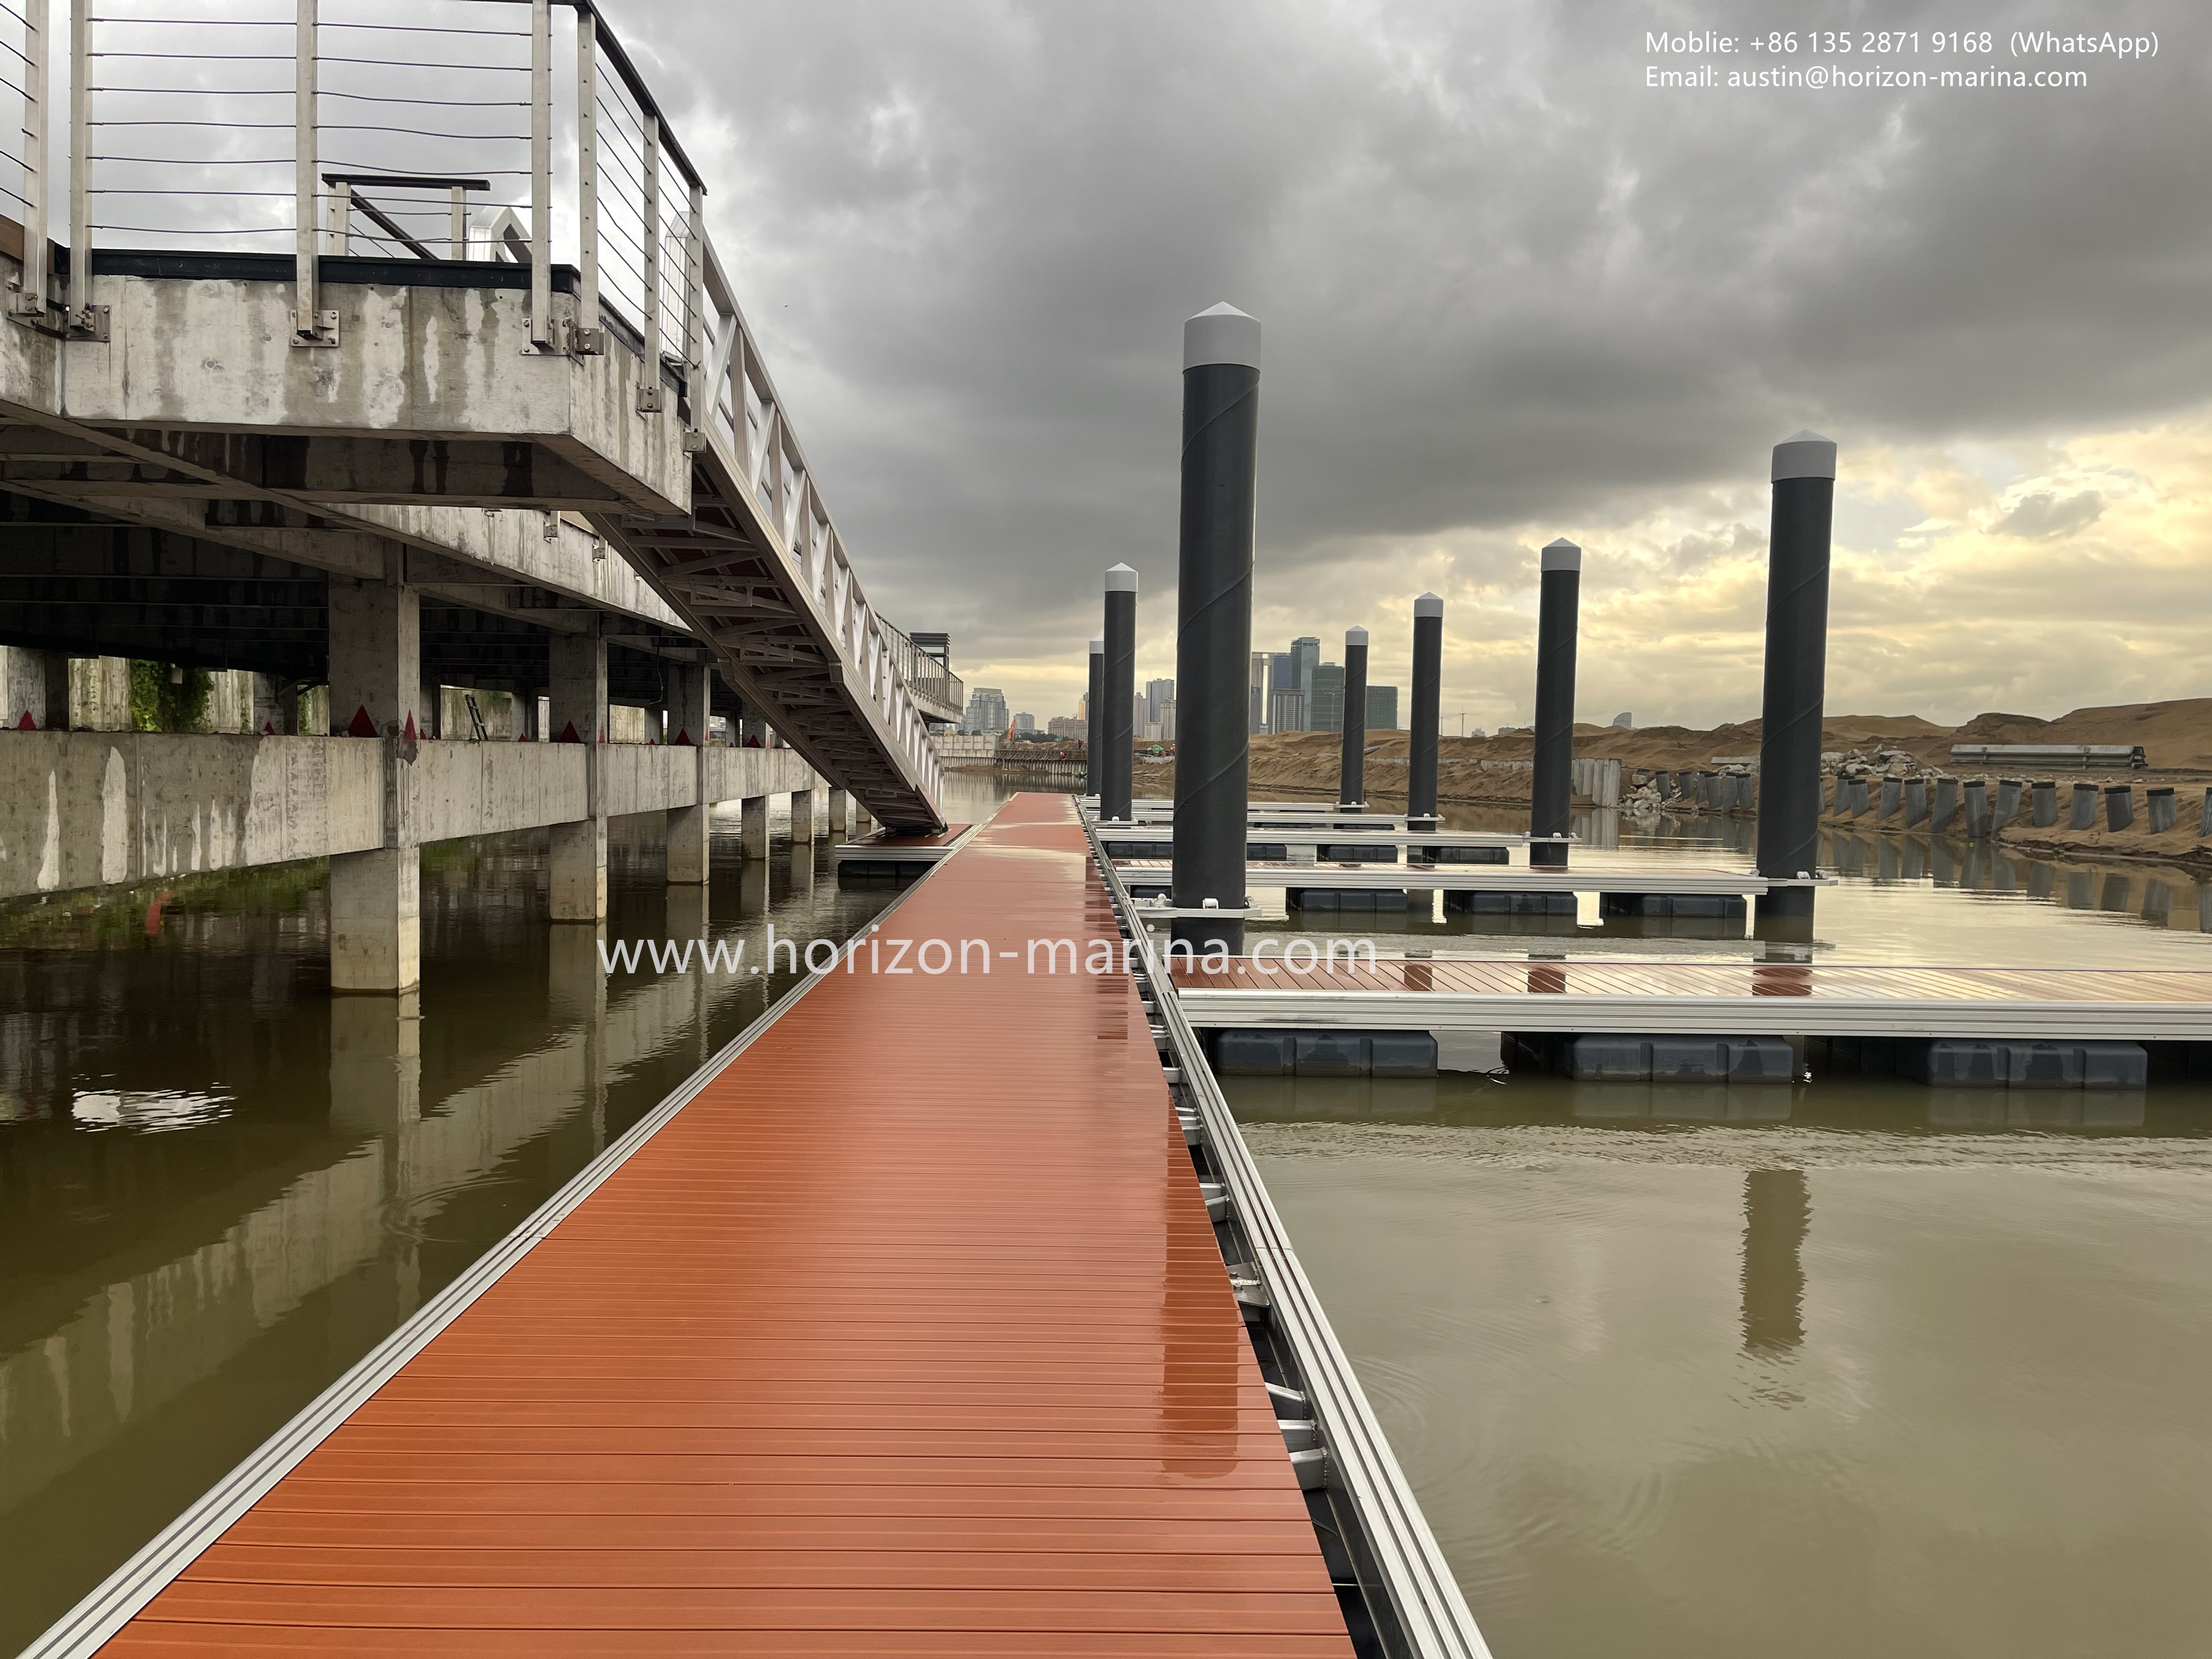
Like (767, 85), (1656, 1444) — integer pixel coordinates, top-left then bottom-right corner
(1226, 1077), (2212, 1659)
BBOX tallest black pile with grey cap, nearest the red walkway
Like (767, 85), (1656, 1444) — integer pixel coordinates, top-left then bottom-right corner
(1177, 305), (1259, 956)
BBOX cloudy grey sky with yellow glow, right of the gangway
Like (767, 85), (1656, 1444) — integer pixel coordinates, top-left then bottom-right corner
(608, 0), (2212, 730)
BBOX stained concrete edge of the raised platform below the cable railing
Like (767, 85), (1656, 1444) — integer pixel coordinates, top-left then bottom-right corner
(43, 269), (690, 513)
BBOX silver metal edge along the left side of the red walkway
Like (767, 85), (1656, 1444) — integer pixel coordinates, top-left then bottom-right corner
(18, 858), (975, 1659)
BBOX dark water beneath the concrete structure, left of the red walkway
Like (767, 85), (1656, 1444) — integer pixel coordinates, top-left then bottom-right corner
(0, 812), (891, 1652)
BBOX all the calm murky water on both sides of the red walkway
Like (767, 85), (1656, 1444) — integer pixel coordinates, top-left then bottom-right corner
(0, 783), (2212, 1659)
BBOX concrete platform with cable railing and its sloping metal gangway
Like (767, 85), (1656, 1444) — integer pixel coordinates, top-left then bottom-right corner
(0, 0), (962, 830)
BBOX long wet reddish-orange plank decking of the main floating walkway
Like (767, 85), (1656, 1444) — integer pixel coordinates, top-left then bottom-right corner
(106, 794), (1352, 1657)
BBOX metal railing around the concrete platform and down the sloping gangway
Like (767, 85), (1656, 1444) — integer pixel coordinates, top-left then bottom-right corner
(0, 0), (960, 819)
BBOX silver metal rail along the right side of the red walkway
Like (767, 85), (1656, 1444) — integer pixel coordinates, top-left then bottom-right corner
(1084, 816), (1491, 1659)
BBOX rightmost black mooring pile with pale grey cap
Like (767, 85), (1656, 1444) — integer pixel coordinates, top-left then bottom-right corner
(1756, 431), (1836, 918)
